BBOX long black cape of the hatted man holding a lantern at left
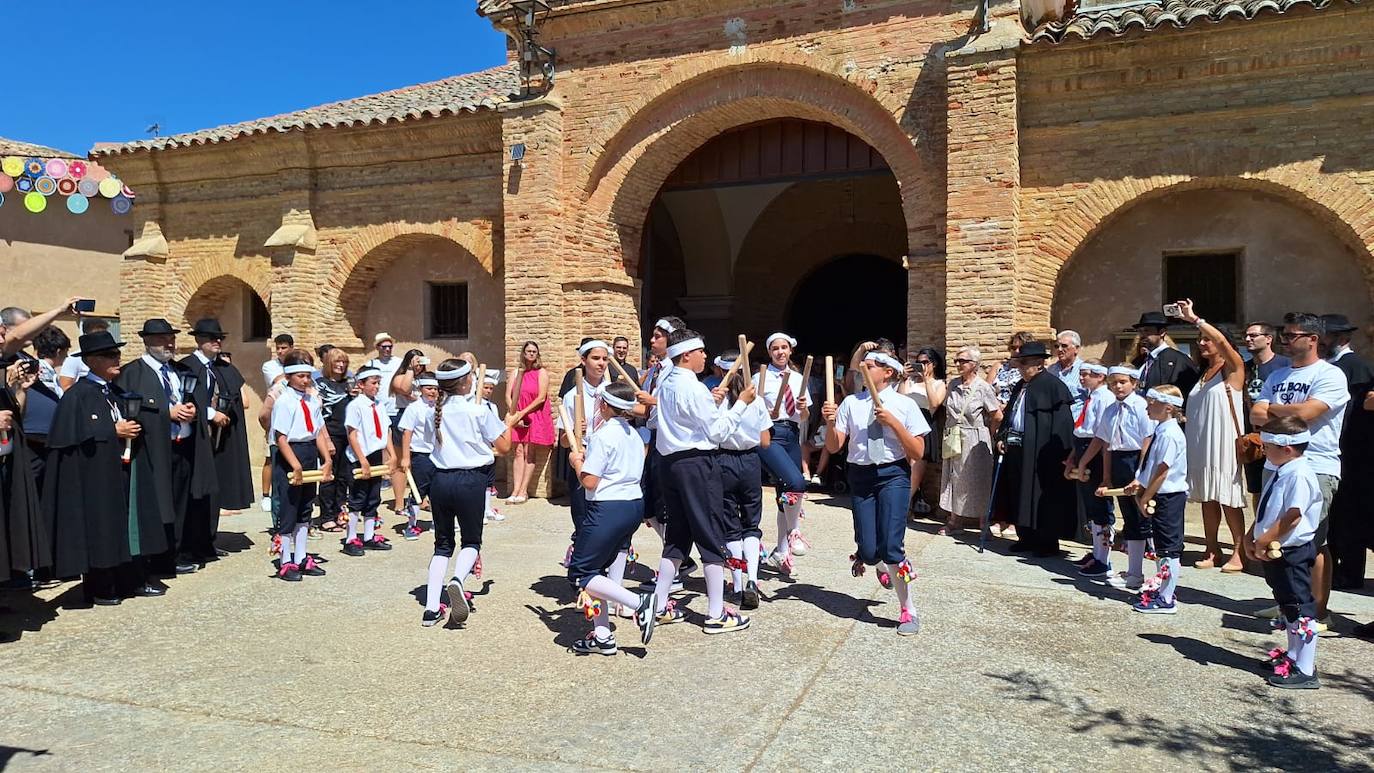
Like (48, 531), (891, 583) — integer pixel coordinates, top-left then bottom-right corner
(43, 379), (166, 577)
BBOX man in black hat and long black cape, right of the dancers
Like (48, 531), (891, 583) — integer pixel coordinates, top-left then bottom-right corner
(993, 341), (1077, 557)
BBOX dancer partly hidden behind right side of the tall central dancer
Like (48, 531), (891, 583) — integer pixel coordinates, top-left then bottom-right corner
(714, 350), (772, 610)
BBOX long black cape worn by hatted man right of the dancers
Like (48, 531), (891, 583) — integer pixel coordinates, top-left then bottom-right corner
(993, 371), (1077, 540)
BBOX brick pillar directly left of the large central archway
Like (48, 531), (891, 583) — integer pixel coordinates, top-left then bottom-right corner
(502, 97), (563, 496)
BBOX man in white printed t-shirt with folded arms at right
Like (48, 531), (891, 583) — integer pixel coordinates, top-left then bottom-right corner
(1250, 313), (1351, 630)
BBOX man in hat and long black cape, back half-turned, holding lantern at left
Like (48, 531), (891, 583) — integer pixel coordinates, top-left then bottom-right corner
(43, 331), (168, 605)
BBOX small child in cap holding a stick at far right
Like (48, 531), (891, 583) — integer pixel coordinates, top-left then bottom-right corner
(1245, 416), (1322, 689)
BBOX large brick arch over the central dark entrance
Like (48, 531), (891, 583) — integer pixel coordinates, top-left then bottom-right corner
(580, 58), (943, 273)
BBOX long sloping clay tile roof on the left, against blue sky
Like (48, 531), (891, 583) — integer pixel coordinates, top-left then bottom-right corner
(91, 66), (519, 157)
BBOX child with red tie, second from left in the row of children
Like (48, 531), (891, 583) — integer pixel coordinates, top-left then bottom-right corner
(344, 368), (396, 556)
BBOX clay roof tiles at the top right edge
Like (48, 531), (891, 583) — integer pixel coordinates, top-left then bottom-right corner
(1029, 0), (1360, 43)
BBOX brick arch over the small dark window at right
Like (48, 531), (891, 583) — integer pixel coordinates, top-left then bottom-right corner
(1022, 169), (1374, 330)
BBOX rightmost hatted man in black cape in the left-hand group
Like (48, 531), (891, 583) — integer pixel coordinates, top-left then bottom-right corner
(179, 319), (253, 564)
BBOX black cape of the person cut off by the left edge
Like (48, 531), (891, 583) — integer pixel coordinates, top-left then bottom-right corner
(0, 386), (52, 579)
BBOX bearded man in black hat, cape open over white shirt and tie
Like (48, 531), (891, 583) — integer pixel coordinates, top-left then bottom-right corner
(118, 319), (216, 577)
